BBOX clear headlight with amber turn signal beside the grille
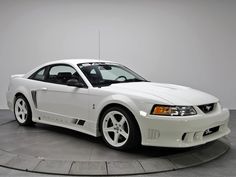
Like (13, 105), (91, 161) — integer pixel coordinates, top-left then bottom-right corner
(151, 105), (197, 116)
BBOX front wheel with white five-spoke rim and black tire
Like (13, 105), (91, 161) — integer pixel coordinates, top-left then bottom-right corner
(100, 107), (140, 150)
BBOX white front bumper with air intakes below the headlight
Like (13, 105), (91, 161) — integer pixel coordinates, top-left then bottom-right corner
(138, 109), (230, 147)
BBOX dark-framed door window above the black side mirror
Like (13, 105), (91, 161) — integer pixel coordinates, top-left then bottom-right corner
(47, 65), (84, 85)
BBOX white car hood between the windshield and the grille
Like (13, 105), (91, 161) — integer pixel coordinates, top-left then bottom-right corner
(104, 82), (219, 105)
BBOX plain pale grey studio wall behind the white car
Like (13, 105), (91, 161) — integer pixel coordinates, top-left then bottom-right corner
(0, 0), (236, 109)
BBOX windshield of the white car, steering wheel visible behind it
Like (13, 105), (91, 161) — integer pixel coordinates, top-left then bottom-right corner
(78, 62), (146, 87)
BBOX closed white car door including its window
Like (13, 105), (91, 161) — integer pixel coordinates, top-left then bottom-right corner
(37, 64), (88, 126)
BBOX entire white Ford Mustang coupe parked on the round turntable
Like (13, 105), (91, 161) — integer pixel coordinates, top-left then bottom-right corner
(7, 59), (230, 149)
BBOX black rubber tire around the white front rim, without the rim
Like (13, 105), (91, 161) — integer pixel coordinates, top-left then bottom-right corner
(100, 106), (141, 150)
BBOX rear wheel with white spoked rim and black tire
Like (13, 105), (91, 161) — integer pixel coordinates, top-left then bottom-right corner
(14, 95), (33, 126)
